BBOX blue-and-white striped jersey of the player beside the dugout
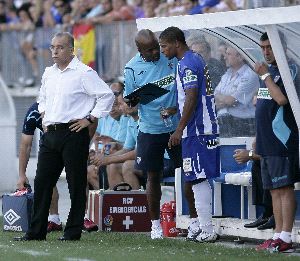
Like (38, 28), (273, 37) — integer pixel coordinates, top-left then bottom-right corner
(176, 50), (219, 138)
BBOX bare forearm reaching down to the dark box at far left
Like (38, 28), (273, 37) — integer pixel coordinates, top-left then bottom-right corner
(17, 133), (33, 189)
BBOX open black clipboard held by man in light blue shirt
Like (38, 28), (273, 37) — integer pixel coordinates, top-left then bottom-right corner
(124, 83), (170, 105)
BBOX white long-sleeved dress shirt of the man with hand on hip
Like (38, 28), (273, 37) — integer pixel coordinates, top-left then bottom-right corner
(38, 56), (114, 126)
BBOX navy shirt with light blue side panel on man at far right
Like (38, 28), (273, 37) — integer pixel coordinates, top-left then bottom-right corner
(255, 64), (299, 157)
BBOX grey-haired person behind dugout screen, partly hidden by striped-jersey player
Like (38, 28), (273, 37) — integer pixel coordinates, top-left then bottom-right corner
(187, 35), (226, 90)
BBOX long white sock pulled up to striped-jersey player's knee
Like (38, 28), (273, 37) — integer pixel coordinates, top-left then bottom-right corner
(192, 180), (213, 233)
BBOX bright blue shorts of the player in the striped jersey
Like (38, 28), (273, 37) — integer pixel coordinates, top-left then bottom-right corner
(182, 135), (220, 183)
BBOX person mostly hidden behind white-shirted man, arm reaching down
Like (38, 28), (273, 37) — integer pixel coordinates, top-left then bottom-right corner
(17, 102), (62, 233)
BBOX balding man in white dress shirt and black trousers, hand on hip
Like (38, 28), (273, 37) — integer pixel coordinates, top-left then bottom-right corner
(15, 32), (114, 241)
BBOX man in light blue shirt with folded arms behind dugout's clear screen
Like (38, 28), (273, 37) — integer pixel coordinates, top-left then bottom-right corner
(214, 47), (259, 137)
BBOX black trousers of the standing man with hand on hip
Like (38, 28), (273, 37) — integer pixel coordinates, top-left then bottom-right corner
(27, 128), (89, 239)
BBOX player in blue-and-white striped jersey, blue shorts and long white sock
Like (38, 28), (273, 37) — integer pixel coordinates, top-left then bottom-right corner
(159, 27), (220, 242)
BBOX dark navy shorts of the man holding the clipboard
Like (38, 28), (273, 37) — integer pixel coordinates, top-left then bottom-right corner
(135, 132), (182, 172)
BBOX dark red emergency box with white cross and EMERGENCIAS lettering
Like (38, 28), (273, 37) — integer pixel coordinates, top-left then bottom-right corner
(88, 190), (151, 232)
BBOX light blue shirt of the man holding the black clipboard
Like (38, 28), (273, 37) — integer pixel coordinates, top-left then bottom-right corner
(124, 53), (178, 134)
